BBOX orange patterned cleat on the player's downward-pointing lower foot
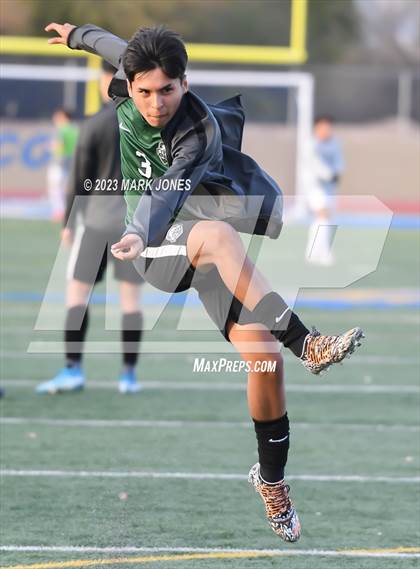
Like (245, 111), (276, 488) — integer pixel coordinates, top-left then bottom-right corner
(248, 462), (300, 542)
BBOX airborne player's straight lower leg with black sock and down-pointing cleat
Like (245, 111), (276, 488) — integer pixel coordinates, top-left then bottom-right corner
(229, 324), (300, 541)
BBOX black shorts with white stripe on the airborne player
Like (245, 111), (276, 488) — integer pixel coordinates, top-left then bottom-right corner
(134, 221), (255, 340)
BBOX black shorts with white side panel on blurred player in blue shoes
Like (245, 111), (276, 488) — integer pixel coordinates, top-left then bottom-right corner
(67, 226), (143, 284)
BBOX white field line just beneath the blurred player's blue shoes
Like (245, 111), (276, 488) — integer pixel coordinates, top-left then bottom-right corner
(1, 380), (420, 395)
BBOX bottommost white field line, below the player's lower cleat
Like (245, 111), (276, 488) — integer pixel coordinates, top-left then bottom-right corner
(0, 545), (420, 558)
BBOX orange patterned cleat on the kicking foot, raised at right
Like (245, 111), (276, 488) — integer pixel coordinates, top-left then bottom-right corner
(301, 328), (365, 374)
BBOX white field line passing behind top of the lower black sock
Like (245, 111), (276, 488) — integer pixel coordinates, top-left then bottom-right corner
(0, 417), (420, 433)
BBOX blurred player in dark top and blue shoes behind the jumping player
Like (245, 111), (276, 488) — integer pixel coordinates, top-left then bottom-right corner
(36, 58), (143, 393)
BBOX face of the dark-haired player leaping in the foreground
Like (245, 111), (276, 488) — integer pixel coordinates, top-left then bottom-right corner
(128, 67), (188, 128)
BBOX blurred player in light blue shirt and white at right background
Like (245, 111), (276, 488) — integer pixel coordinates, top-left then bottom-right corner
(303, 115), (344, 266)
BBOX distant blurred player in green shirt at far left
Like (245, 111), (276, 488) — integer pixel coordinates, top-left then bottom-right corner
(47, 109), (79, 222)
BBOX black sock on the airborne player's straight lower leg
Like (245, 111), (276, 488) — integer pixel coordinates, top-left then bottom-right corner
(253, 413), (289, 483)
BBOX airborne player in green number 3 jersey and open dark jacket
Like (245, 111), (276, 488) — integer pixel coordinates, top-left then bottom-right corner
(45, 23), (363, 541)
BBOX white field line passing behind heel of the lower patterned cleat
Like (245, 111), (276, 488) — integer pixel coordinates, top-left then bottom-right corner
(0, 469), (420, 484)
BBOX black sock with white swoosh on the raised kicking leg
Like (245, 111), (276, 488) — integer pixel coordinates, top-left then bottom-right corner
(252, 292), (309, 358)
